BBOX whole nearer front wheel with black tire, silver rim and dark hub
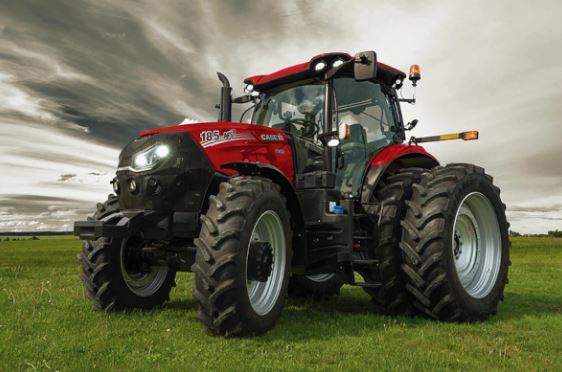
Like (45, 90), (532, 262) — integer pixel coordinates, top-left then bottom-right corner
(192, 177), (292, 336)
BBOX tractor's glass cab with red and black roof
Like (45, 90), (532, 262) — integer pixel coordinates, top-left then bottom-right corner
(246, 53), (406, 197)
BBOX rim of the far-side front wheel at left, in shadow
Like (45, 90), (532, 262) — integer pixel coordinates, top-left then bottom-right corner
(120, 240), (168, 297)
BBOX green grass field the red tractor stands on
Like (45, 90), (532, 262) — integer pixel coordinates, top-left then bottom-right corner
(0, 237), (562, 371)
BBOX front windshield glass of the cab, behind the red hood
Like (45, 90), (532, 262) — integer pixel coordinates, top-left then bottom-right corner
(252, 83), (324, 139)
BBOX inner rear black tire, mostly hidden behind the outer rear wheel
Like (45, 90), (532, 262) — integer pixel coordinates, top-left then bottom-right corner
(361, 168), (427, 315)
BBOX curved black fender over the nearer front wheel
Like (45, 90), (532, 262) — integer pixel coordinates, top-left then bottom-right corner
(222, 162), (308, 275)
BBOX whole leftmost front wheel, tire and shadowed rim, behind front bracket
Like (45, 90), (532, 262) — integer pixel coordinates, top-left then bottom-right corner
(80, 195), (175, 311)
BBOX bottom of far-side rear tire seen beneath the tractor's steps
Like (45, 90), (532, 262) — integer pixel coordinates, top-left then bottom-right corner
(289, 273), (343, 300)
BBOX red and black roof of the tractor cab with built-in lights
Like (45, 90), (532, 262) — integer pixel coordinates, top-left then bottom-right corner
(244, 52), (406, 91)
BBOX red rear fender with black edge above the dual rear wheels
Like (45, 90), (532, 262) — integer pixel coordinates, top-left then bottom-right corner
(361, 144), (439, 205)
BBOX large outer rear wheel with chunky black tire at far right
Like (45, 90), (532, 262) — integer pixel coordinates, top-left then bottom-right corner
(400, 164), (510, 321)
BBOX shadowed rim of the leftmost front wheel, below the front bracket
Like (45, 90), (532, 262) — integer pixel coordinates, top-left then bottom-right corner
(120, 240), (168, 297)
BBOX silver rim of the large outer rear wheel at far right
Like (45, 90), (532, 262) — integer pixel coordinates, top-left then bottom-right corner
(451, 192), (502, 298)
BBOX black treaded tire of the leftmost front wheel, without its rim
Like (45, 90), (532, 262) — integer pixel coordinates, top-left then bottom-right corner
(79, 195), (176, 311)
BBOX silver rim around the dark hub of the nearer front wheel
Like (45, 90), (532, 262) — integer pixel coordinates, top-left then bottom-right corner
(246, 211), (286, 316)
